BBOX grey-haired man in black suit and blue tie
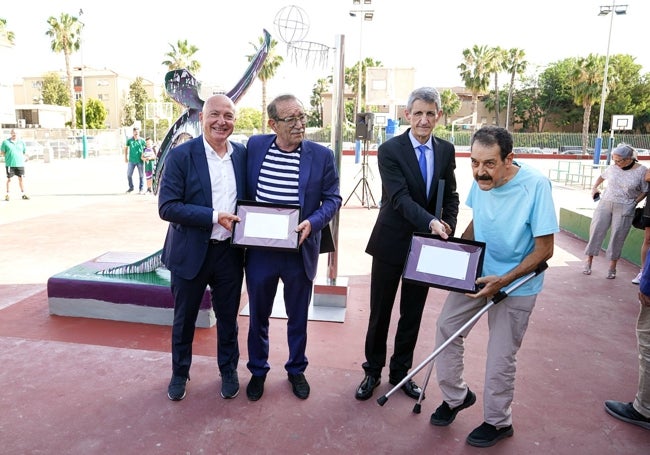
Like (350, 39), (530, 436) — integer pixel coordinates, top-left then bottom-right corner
(355, 87), (459, 400)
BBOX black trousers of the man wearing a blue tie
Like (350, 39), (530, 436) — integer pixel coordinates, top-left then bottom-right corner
(363, 258), (429, 381)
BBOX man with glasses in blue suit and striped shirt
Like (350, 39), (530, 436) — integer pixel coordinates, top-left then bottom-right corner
(246, 95), (341, 401)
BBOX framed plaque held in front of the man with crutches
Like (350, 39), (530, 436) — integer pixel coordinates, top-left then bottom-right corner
(402, 232), (485, 294)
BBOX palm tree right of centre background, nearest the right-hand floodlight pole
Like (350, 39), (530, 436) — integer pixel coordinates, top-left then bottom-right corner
(571, 54), (605, 153)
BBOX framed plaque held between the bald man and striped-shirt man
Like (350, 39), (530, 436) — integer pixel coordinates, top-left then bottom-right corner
(231, 200), (300, 251)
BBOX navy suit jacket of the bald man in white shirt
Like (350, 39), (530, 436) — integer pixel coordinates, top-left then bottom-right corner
(158, 135), (246, 280)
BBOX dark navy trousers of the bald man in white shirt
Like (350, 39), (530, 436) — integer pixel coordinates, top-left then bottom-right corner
(171, 242), (244, 378)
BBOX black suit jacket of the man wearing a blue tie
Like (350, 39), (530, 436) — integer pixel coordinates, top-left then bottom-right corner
(366, 129), (460, 265)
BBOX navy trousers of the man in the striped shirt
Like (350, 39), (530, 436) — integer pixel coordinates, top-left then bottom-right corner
(246, 249), (313, 376)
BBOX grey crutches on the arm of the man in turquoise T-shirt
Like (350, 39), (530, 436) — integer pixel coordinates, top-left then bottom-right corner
(377, 262), (548, 414)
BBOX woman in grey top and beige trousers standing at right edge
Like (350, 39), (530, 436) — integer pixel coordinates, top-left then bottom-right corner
(582, 144), (648, 280)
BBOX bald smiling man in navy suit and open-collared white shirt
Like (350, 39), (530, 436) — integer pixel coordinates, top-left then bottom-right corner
(158, 95), (246, 401)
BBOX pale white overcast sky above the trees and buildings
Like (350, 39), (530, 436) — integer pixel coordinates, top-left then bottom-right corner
(0, 0), (650, 108)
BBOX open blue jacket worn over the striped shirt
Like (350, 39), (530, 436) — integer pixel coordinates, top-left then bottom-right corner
(246, 134), (342, 280)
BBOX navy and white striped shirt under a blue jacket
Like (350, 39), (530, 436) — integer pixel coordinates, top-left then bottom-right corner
(255, 142), (300, 205)
